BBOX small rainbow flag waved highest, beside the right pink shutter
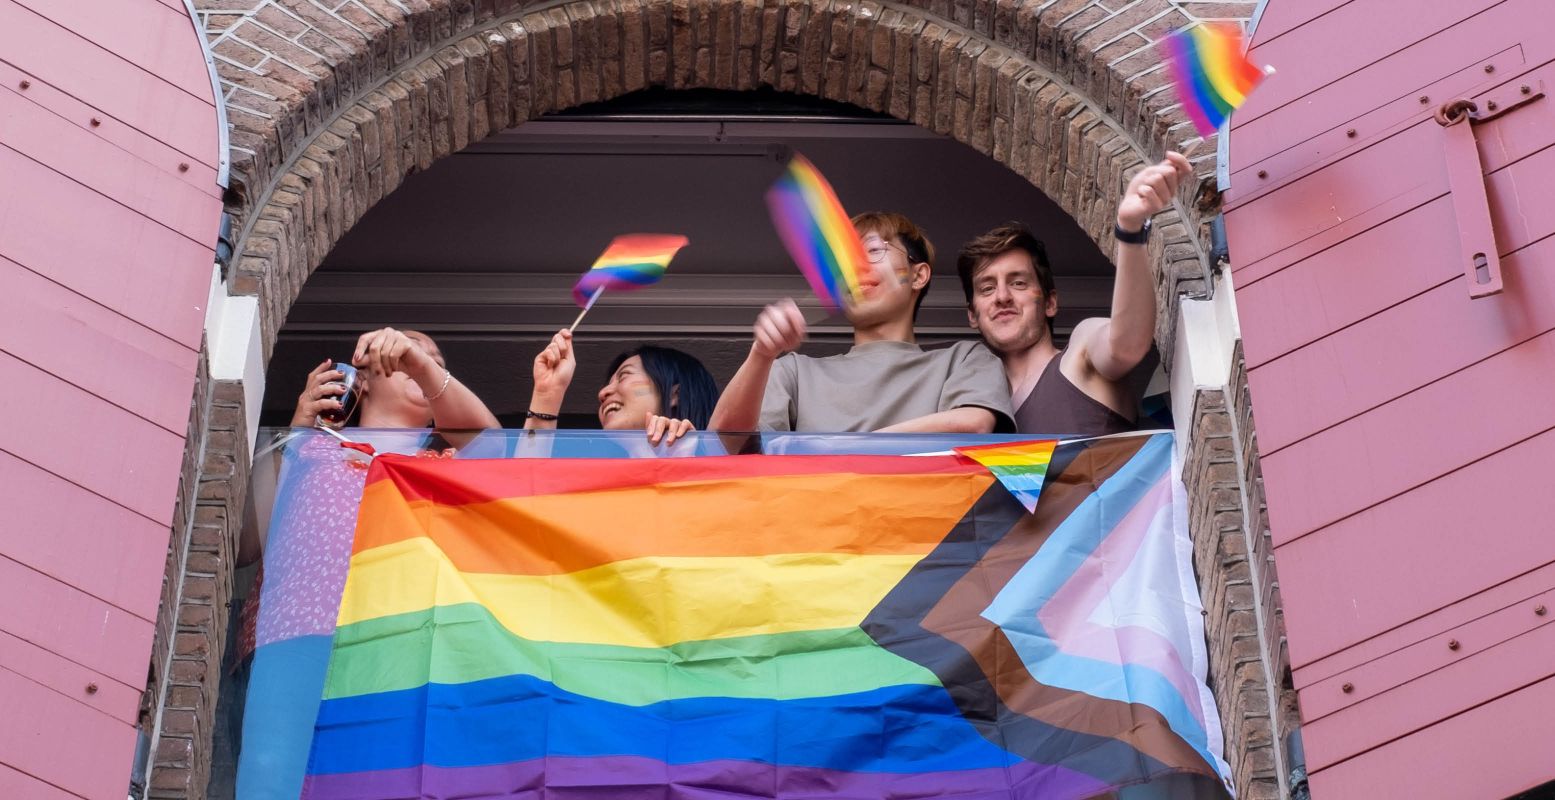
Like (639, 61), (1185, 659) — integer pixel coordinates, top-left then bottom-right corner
(1162, 22), (1264, 137)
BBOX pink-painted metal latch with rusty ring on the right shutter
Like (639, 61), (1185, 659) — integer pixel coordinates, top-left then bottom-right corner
(1435, 82), (1544, 297)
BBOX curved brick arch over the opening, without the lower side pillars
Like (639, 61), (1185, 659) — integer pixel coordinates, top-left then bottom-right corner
(196, 0), (1250, 360)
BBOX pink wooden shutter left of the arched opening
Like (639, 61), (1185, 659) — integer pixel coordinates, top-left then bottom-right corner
(0, 0), (221, 790)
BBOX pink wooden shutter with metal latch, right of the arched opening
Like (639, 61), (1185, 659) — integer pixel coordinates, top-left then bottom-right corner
(1225, 0), (1555, 800)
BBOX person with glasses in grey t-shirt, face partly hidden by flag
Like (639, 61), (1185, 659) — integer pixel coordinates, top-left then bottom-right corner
(709, 212), (1014, 433)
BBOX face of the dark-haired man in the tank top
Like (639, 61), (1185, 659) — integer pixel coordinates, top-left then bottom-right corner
(967, 249), (1059, 353)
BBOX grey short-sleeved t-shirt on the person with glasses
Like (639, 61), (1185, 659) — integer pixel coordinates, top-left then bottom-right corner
(760, 341), (1015, 433)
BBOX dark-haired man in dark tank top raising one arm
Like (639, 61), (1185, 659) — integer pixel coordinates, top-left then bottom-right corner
(956, 153), (1193, 436)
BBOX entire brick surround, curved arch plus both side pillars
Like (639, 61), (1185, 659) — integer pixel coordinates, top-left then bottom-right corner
(149, 0), (1283, 798)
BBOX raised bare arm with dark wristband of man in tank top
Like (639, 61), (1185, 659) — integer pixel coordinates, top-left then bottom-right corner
(1075, 153), (1193, 381)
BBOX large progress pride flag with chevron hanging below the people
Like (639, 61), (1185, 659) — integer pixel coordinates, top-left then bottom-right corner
(289, 434), (1227, 800)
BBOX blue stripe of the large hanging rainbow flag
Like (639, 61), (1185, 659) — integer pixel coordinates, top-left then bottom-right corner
(311, 675), (1019, 774)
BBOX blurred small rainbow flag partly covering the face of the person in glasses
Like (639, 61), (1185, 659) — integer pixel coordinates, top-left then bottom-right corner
(767, 154), (869, 311)
